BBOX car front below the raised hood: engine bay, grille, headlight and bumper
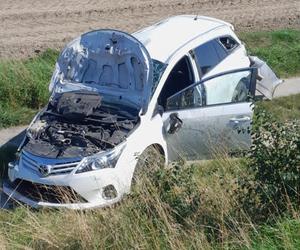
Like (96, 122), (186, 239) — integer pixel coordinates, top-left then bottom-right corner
(3, 91), (139, 208)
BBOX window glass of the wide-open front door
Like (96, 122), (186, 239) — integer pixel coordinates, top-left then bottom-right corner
(167, 69), (252, 110)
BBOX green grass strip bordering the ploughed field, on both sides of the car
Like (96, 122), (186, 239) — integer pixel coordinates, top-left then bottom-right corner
(0, 30), (300, 128)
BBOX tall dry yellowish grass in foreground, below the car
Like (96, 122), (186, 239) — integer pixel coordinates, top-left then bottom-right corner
(0, 156), (300, 249)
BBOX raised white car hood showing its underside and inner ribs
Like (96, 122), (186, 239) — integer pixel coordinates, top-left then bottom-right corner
(49, 29), (153, 113)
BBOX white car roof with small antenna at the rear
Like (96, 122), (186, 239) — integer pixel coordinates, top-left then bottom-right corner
(132, 15), (233, 63)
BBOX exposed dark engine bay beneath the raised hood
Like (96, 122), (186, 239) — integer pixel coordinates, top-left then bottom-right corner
(23, 91), (139, 158)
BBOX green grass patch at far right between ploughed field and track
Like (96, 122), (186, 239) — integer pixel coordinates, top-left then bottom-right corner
(240, 30), (300, 78)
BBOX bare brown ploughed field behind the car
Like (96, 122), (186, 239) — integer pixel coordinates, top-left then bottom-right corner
(0, 0), (300, 57)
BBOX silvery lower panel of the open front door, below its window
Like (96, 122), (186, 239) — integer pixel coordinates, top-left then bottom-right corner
(163, 103), (252, 161)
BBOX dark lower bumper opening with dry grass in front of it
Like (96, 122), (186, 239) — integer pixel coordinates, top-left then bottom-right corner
(11, 179), (87, 204)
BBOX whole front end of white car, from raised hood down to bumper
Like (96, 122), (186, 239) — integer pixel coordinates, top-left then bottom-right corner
(3, 30), (153, 209)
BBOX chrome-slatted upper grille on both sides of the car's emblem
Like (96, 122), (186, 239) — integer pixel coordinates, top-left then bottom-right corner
(21, 153), (79, 175)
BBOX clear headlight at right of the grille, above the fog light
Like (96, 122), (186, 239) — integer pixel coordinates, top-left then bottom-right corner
(76, 144), (125, 174)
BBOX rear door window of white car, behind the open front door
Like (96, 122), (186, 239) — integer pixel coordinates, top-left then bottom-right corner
(194, 40), (227, 75)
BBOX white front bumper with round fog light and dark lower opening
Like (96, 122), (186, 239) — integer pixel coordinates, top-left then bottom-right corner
(3, 152), (130, 209)
